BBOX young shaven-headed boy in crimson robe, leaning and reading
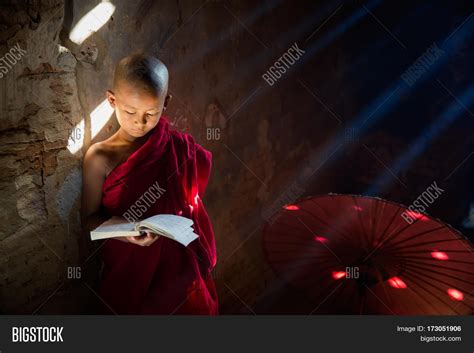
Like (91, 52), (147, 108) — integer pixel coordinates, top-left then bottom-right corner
(81, 54), (218, 315)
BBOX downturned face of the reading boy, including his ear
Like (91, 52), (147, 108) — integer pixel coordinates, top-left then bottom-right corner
(107, 82), (170, 137)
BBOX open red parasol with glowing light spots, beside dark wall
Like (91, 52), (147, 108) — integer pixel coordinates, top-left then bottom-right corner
(263, 194), (474, 315)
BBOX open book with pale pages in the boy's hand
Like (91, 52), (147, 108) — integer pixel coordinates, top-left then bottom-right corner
(91, 214), (198, 246)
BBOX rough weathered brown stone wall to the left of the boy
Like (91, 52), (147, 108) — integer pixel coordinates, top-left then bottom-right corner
(0, 1), (82, 313)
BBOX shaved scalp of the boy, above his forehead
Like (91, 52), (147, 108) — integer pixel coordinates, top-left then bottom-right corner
(114, 53), (168, 97)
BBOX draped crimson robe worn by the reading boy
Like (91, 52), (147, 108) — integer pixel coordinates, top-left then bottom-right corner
(99, 116), (218, 315)
